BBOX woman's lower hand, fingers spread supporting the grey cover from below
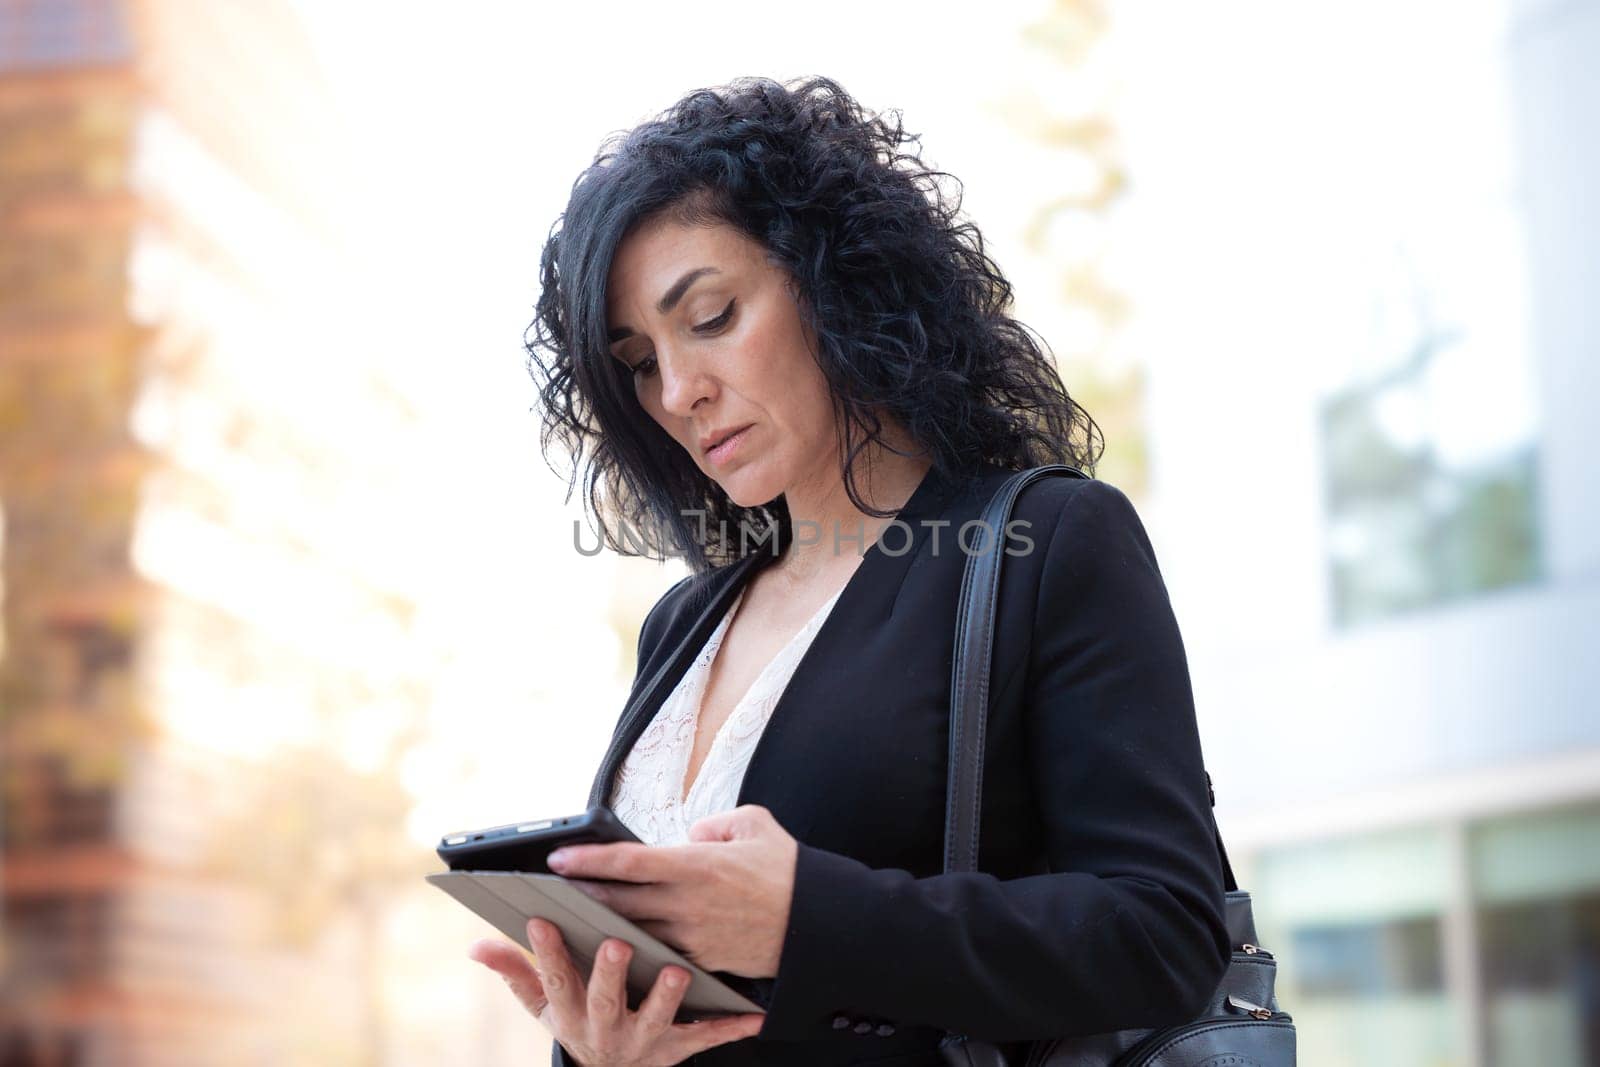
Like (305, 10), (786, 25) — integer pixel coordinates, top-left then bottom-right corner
(469, 918), (765, 1067)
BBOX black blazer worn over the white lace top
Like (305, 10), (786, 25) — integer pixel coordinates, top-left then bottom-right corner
(552, 466), (1230, 1067)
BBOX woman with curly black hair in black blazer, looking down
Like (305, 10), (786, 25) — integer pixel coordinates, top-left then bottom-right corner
(472, 78), (1229, 1067)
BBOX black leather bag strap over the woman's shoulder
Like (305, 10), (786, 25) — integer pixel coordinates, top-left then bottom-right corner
(944, 464), (1238, 891)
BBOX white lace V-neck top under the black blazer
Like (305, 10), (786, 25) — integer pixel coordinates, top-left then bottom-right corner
(610, 589), (845, 845)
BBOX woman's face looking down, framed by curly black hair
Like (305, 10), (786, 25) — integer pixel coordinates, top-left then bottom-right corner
(606, 219), (838, 507)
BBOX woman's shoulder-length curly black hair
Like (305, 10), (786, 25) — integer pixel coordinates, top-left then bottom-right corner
(523, 77), (1104, 573)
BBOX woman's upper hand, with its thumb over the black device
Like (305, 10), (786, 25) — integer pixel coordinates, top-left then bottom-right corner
(549, 805), (800, 977)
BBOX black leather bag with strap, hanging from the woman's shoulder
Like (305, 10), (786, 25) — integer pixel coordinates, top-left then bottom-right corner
(939, 464), (1294, 1067)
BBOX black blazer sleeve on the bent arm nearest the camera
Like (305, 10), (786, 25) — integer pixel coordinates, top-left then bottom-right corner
(760, 482), (1230, 1041)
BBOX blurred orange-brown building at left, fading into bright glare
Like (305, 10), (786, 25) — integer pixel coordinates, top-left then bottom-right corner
(0, 0), (427, 1067)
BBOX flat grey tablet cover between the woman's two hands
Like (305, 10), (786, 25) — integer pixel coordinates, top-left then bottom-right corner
(427, 870), (763, 1019)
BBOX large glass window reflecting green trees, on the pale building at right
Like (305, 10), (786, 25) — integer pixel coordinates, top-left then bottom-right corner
(1312, 3), (1544, 627)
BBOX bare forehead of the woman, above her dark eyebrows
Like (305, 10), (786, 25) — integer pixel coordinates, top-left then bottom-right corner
(606, 219), (762, 322)
